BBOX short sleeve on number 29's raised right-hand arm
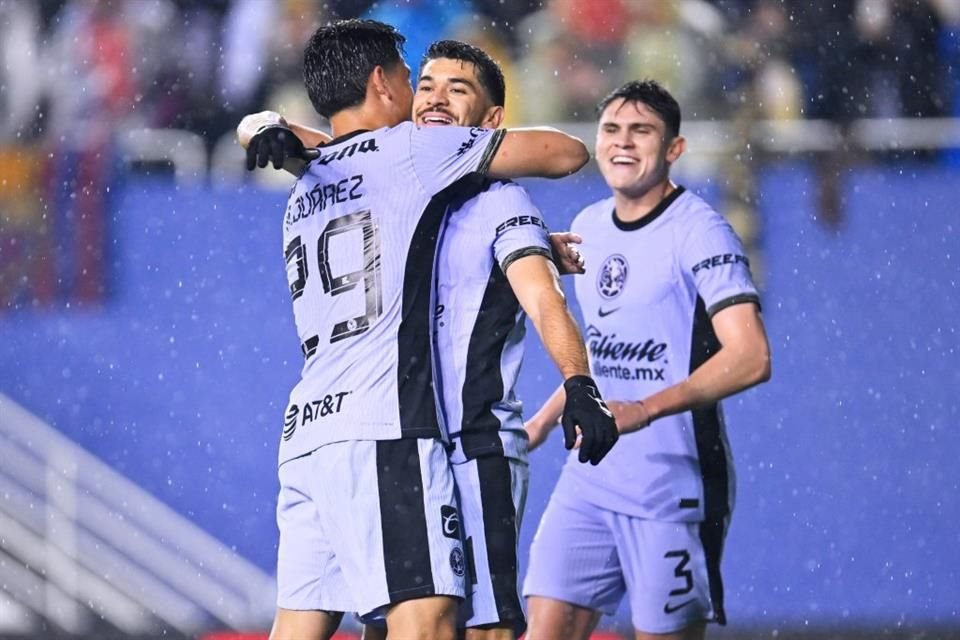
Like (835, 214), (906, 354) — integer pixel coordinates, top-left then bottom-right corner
(410, 126), (505, 196)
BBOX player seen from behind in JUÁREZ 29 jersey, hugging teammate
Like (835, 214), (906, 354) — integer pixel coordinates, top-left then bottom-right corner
(250, 20), (615, 640)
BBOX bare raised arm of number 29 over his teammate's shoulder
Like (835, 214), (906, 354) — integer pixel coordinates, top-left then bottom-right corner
(487, 127), (590, 178)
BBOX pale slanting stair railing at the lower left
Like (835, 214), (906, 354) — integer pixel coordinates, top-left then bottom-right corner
(0, 394), (274, 634)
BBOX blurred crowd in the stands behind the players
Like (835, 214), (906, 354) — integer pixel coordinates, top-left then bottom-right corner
(0, 0), (960, 145)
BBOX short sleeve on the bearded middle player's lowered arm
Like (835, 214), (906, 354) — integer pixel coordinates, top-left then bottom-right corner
(483, 182), (553, 273)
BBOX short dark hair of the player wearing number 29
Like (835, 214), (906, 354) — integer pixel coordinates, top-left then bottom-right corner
(303, 19), (406, 118)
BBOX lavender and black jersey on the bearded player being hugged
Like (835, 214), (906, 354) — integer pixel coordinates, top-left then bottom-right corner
(435, 181), (552, 462)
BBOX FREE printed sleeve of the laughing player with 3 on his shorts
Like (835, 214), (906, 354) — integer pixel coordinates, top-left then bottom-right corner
(680, 213), (760, 317)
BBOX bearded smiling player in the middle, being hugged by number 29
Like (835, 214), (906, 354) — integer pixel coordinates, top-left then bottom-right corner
(247, 40), (616, 640)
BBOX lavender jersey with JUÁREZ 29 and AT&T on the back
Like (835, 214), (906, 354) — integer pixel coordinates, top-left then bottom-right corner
(280, 122), (503, 463)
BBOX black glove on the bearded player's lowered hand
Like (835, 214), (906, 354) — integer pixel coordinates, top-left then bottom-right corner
(560, 376), (620, 464)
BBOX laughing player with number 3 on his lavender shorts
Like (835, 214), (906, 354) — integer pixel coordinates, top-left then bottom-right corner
(523, 81), (770, 640)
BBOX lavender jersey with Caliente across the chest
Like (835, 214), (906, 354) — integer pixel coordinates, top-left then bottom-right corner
(557, 187), (759, 522)
